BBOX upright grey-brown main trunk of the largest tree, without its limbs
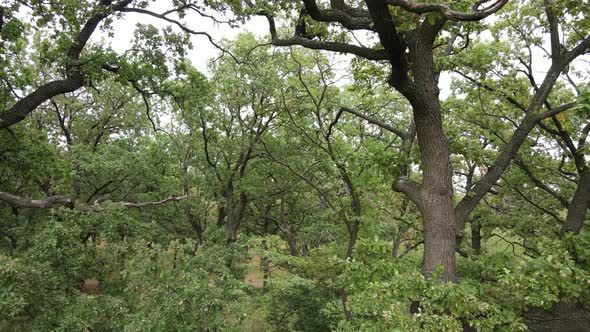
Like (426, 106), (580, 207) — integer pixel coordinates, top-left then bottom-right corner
(396, 27), (456, 281)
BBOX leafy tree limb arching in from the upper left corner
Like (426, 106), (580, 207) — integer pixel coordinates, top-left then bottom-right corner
(0, 0), (240, 129)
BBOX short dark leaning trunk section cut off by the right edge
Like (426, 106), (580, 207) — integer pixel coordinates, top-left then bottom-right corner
(565, 170), (590, 234)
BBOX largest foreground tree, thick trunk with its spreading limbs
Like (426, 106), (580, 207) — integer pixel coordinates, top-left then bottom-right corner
(239, 0), (590, 281)
